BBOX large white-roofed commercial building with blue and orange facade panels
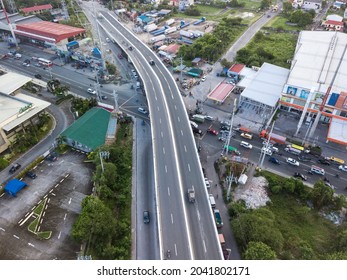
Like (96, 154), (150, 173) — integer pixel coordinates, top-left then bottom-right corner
(280, 31), (347, 145)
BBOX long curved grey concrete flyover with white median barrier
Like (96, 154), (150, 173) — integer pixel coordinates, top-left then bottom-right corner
(98, 11), (223, 260)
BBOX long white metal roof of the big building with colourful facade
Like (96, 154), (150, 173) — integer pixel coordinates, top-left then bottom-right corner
(287, 31), (347, 93)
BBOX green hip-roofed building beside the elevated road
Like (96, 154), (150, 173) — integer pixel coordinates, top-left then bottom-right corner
(61, 107), (111, 152)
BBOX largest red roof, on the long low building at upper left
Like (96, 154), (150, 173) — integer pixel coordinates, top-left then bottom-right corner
(16, 21), (85, 43)
